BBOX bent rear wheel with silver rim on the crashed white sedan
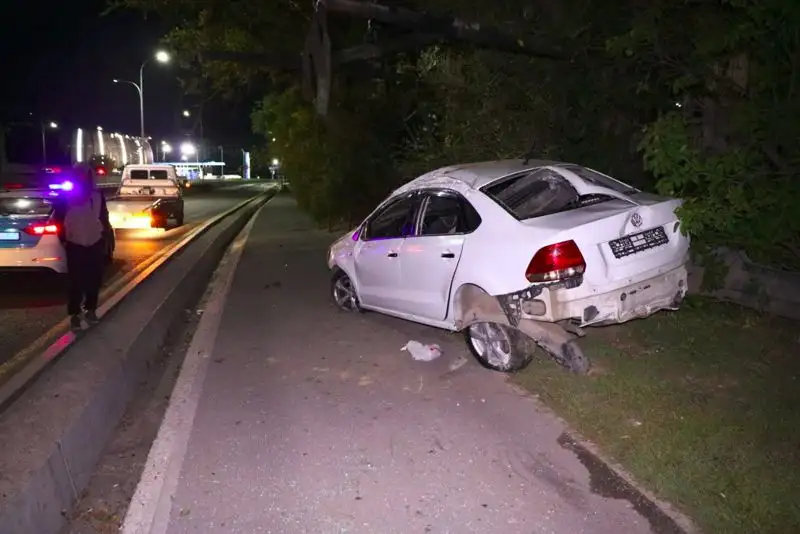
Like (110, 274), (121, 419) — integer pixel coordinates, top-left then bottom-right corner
(464, 322), (537, 373)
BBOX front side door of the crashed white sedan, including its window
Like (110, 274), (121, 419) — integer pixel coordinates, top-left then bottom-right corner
(353, 194), (419, 310)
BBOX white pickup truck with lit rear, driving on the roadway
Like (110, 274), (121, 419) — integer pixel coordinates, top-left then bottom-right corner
(108, 164), (183, 229)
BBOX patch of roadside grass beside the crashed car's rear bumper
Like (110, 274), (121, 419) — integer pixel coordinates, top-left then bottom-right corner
(514, 298), (800, 534)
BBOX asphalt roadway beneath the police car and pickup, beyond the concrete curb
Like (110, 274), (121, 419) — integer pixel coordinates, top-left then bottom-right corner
(0, 185), (264, 365)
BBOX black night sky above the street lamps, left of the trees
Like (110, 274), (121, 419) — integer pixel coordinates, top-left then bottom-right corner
(0, 0), (255, 163)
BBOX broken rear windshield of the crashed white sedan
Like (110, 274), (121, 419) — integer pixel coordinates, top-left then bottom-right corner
(482, 169), (580, 220)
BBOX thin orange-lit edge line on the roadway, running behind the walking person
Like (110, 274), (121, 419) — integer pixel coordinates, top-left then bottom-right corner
(0, 189), (278, 410)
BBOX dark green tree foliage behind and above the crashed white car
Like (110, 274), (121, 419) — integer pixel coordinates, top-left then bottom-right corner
(112, 0), (800, 269)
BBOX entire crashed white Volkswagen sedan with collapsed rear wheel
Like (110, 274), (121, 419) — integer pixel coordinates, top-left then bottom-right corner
(328, 160), (689, 373)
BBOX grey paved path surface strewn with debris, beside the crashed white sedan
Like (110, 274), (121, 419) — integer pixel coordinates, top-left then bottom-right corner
(127, 196), (658, 534)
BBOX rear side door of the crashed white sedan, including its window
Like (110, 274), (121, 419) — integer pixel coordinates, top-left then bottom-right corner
(399, 191), (480, 321)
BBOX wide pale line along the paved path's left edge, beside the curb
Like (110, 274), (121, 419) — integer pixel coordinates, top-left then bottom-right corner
(120, 197), (269, 534)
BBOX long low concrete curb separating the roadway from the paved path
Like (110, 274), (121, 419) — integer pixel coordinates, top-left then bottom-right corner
(0, 195), (266, 534)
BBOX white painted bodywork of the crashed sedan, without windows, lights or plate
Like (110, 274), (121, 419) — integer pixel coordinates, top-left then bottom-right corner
(328, 160), (689, 330)
